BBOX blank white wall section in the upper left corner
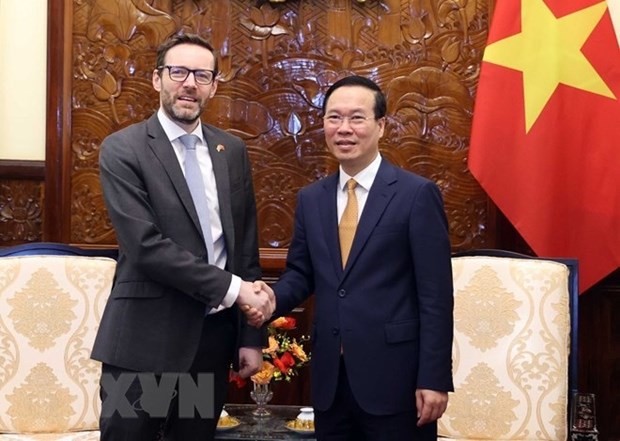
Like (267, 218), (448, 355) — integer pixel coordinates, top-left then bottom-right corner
(0, 0), (47, 160)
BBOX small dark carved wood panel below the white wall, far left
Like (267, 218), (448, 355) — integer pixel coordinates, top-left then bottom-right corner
(0, 179), (43, 245)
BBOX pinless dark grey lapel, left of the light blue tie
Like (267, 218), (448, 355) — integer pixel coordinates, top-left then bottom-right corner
(146, 114), (202, 237)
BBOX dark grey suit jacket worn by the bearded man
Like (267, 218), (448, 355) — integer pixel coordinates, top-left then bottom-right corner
(92, 115), (264, 440)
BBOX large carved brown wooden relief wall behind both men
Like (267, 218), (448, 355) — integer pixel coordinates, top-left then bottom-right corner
(71, 0), (492, 249)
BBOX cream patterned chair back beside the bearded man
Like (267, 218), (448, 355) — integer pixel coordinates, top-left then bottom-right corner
(0, 246), (116, 441)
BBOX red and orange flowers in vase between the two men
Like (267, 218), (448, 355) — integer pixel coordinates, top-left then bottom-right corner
(230, 317), (310, 387)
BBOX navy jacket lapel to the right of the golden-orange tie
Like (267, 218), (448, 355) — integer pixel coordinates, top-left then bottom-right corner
(344, 160), (396, 277)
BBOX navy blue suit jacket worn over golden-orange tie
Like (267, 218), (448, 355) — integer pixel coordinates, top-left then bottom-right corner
(274, 159), (453, 436)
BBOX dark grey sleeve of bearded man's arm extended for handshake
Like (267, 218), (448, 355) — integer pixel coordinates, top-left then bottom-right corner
(99, 133), (231, 307)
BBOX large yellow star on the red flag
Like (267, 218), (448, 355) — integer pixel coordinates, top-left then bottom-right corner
(483, 0), (615, 132)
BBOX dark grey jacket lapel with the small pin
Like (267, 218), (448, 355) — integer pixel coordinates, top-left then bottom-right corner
(202, 124), (235, 257)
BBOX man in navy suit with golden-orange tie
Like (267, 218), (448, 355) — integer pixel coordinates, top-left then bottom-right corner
(260, 76), (453, 441)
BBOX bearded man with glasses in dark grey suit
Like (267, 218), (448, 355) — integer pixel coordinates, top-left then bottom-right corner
(92, 34), (275, 441)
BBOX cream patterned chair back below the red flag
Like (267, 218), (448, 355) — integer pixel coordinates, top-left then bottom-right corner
(439, 251), (577, 441)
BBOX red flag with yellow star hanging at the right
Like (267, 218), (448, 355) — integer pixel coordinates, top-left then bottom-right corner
(468, 0), (620, 292)
